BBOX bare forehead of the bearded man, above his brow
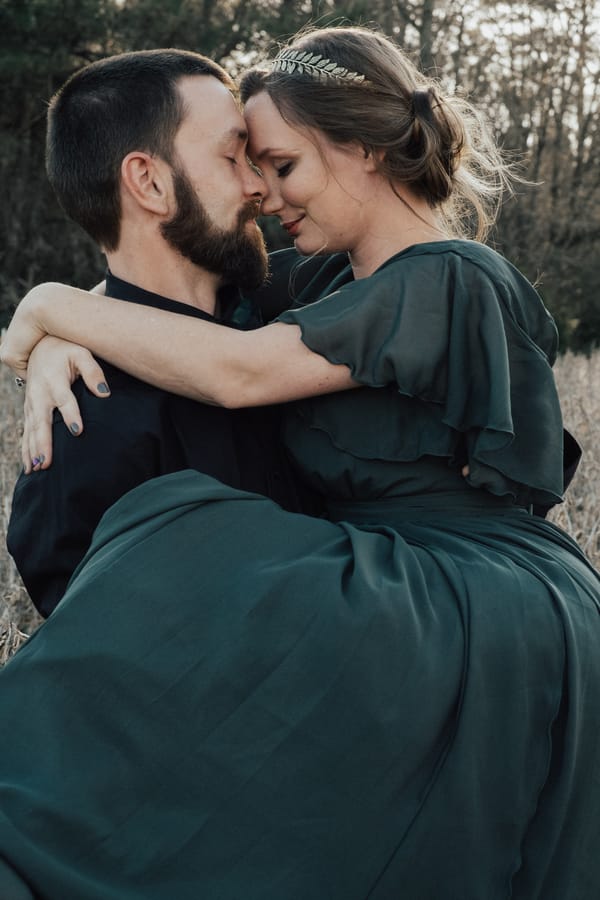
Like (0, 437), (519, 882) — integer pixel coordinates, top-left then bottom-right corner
(176, 75), (248, 149)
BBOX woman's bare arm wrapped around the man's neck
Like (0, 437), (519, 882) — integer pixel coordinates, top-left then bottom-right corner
(1, 284), (356, 408)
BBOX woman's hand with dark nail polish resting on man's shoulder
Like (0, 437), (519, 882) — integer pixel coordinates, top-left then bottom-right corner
(21, 337), (110, 475)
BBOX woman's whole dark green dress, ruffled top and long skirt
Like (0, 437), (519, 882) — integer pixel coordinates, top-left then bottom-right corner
(0, 241), (600, 900)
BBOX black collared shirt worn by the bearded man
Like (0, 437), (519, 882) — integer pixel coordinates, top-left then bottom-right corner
(7, 273), (315, 616)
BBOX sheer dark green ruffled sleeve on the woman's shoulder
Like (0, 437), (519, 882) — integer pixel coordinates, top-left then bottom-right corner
(279, 241), (563, 503)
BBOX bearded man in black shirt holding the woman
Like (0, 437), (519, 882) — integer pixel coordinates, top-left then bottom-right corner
(7, 50), (326, 616)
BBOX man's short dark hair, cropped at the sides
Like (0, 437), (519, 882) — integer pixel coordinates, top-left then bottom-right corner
(46, 49), (234, 250)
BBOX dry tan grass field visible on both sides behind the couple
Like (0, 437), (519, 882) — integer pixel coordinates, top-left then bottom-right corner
(0, 351), (600, 665)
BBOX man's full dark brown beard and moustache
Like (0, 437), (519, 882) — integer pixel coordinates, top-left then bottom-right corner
(160, 166), (268, 290)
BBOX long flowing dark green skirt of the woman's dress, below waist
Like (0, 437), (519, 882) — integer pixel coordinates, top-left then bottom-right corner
(0, 472), (600, 900)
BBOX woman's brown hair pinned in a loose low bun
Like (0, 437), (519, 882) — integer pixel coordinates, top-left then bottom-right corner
(240, 27), (513, 240)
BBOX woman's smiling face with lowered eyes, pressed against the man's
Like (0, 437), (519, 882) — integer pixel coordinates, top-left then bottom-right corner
(244, 91), (372, 254)
